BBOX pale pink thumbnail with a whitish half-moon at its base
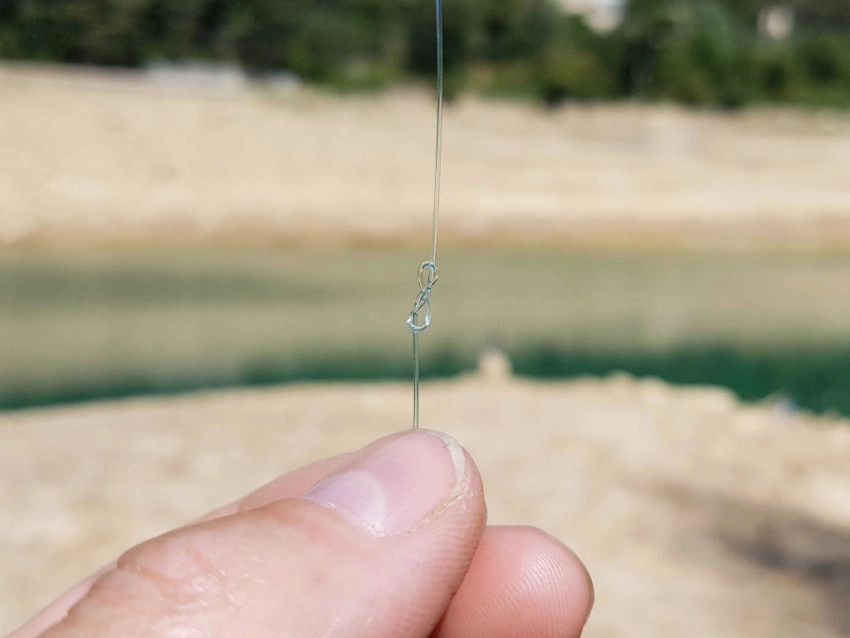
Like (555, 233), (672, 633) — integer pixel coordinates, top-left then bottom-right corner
(304, 430), (466, 536)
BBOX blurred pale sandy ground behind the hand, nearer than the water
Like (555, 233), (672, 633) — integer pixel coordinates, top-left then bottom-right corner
(0, 376), (850, 638)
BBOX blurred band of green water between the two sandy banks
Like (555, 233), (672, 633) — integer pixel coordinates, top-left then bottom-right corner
(0, 246), (850, 414)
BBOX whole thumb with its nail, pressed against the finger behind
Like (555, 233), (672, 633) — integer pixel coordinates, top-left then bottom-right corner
(44, 431), (485, 638)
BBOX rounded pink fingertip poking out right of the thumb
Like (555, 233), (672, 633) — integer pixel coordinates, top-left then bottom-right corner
(433, 527), (593, 638)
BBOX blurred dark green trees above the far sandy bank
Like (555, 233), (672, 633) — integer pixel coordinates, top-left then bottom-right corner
(0, 0), (850, 107)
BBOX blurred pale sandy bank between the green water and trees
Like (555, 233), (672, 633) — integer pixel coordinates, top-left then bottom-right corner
(0, 66), (850, 245)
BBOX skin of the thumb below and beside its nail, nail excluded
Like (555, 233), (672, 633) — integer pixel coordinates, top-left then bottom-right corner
(38, 435), (485, 638)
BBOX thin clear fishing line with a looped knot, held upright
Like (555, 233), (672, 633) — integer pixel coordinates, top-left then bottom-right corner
(407, 0), (443, 430)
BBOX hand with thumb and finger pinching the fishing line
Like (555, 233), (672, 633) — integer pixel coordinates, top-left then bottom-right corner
(8, 430), (593, 638)
